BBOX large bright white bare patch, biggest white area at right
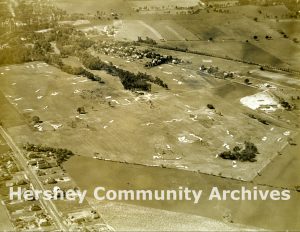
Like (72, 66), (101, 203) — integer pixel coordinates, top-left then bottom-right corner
(240, 92), (280, 112)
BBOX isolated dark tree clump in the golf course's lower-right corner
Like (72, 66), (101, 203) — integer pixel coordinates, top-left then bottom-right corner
(219, 142), (259, 162)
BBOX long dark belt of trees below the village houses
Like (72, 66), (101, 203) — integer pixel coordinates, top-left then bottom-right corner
(81, 53), (168, 91)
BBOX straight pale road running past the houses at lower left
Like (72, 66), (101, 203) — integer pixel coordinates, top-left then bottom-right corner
(0, 126), (68, 231)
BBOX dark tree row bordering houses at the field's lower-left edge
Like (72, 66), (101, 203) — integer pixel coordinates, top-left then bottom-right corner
(23, 143), (74, 165)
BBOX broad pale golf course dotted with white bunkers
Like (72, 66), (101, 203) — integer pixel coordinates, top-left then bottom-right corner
(0, 56), (293, 180)
